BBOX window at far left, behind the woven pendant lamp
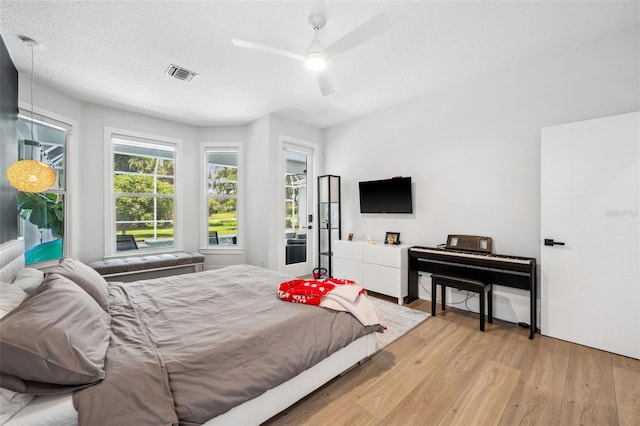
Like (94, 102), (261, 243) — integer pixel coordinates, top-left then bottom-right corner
(17, 110), (71, 264)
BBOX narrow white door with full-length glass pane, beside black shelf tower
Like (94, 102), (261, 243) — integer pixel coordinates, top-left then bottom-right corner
(280, 143), (315, 277)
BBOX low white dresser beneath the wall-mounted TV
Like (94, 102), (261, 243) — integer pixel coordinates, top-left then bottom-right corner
(333, 240), (411, 305)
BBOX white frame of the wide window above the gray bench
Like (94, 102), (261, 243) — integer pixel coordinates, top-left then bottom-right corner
(104, 127), (184, 258)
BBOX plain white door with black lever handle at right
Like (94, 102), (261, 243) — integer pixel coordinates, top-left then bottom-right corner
(540, 113), (640, 358)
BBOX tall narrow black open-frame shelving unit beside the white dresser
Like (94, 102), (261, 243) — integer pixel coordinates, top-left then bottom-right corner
(318, 175), (342, 277)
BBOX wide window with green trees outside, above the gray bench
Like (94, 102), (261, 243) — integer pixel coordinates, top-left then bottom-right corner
(107, 133), (178, 253)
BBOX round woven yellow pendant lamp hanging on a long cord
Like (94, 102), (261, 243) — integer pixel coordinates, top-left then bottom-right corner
(7, 37), (56, 192)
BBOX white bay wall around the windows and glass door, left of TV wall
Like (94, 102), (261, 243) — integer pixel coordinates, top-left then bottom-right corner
(19, 80), (323, 269)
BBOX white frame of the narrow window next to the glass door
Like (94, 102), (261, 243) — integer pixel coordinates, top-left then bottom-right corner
(199, 142), (246, 254)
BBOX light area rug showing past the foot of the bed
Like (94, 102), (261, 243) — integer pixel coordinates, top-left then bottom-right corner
(370, 297), (430, 351)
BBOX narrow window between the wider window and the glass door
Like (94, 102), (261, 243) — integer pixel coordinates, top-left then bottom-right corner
(204, 146), (241, 246)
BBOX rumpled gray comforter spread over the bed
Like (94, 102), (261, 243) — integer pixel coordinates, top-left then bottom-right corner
(74, 266), (378, 426)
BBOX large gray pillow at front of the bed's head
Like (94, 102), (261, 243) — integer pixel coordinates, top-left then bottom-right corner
(0, 274), (111, 393)
